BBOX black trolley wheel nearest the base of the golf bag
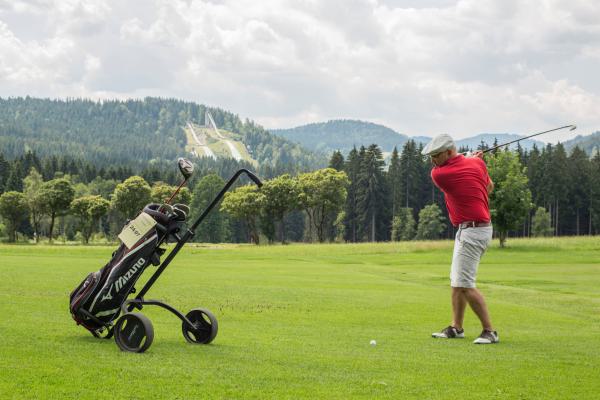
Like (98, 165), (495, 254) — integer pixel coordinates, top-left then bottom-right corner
(114, 313), (154, 353)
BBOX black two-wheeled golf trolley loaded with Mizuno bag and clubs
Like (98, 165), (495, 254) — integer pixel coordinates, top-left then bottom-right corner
(69, 158), (262, 353)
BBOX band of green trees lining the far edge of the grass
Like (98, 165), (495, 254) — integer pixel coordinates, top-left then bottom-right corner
(0, 140), (600, 247)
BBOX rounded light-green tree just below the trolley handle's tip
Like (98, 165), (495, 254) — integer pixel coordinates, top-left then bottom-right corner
(221, 185), (264, 244)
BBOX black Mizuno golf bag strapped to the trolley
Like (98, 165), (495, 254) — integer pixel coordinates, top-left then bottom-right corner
(70, 204), (183, 336)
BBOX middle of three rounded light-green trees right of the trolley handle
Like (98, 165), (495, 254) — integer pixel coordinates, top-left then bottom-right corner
(261, 174), (300, 243)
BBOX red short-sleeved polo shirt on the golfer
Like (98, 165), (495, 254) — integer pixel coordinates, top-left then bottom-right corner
(431, 154), (491, 226)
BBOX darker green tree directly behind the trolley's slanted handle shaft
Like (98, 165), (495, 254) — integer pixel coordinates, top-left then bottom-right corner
(190, 174), (229, 243)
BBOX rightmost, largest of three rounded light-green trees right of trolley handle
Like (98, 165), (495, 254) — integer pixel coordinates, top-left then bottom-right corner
(298, 168), (350, 243)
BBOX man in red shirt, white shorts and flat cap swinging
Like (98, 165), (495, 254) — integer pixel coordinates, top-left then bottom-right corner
(422, 135), (499, 344)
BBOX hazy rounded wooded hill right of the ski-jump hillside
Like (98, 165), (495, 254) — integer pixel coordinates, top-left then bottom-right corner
(270, 120), (409, 154)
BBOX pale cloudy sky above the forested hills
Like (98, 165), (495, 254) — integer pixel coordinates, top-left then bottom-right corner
(0, 0), (600, 141)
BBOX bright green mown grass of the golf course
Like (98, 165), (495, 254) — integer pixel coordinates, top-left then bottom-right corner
(0, 237), (600, 399)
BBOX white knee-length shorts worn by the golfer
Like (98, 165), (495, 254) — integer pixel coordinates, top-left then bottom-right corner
(450, 225), (494, 288)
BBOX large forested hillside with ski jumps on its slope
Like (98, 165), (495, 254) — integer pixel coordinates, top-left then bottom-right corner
(0, 97), (327, 170)
